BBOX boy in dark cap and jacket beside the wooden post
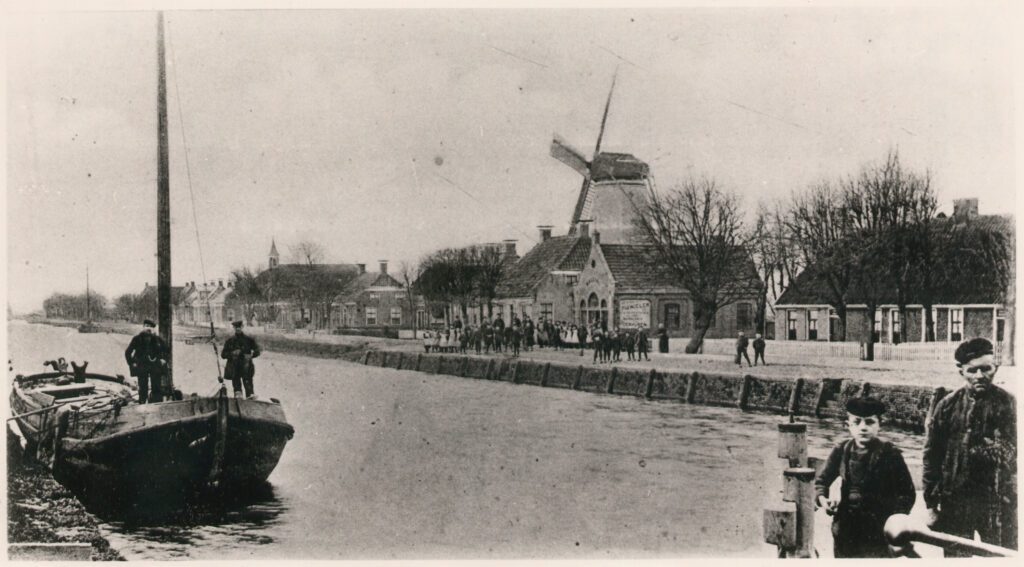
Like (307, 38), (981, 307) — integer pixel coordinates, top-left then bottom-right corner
(814, 398), (916, 558)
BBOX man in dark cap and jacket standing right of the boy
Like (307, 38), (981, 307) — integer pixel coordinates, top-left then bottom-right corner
(924, 338), (1017, 557)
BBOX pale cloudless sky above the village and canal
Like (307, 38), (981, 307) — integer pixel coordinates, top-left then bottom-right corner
(4, 4), (1020, 312)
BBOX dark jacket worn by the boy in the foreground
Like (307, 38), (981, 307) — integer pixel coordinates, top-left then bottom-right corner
(814, 439), (918, 522)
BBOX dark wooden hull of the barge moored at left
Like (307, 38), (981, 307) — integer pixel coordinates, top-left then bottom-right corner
(11, 370), (294, 508)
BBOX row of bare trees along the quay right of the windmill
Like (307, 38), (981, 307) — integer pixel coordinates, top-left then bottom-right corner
(635, 147), (1014, 356)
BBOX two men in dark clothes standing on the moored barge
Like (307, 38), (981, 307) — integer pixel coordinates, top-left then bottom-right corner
(125, 319), (260, 403)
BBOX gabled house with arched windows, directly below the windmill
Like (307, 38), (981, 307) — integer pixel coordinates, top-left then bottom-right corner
(573, 231), (758, 339)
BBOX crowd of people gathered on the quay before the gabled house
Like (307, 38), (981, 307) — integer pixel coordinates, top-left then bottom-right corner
(423, 314), (650, 363)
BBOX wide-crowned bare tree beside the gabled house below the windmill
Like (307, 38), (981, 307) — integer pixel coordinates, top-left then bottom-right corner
(636, 178), (758, 353)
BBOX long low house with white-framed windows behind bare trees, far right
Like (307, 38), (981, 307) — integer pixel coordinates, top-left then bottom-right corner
(775, 199), (1014, 344)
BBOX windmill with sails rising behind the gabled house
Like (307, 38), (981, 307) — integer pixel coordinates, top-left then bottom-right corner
(551, 71), (651, 244)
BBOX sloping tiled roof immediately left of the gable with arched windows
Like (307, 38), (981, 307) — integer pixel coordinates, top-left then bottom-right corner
(496, 236), (591, 298)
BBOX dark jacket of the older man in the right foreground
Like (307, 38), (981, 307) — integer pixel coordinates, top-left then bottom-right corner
(923, 386), (1017, 508)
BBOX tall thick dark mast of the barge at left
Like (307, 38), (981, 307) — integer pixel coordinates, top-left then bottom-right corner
(157, 12), (174, 386)
